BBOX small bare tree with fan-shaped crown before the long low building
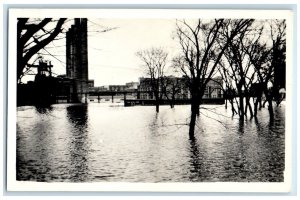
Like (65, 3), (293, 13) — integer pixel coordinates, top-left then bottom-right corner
(137, 48), (168, 112)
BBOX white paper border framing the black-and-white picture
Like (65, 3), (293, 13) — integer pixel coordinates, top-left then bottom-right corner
(7, 9), (295, 192)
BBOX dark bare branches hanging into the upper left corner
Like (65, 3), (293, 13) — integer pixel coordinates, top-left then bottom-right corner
(17, 18), (66, 82)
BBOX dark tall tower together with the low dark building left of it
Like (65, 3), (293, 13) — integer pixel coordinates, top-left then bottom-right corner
(18, 18), (94, 105)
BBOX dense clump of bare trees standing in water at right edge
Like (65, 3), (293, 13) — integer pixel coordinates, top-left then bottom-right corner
(218, 20), (285, 119)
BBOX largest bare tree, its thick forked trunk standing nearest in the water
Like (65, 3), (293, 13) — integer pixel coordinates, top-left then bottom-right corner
(174, 19), (253, 139)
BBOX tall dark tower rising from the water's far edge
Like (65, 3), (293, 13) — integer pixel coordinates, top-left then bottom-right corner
(66, 18), (88, 102)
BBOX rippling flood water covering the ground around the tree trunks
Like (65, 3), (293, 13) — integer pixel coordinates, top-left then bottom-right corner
(17, 103), (285, 182)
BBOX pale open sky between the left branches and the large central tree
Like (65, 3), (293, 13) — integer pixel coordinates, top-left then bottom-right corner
(23, 19), (178, 86)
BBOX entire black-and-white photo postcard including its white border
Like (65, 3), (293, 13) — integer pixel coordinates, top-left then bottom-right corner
(7, 9), (292, 192)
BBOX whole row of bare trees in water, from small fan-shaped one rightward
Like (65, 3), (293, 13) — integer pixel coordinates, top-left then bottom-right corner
(137, 19), (286, 138)
